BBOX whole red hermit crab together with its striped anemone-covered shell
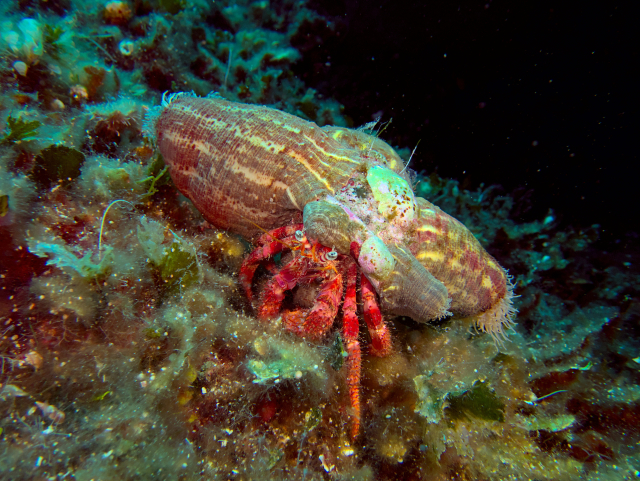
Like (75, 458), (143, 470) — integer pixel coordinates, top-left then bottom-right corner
(149, 94), (516, 437)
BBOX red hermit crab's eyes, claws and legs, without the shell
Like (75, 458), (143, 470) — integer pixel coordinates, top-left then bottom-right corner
(240, 224), (391, 437)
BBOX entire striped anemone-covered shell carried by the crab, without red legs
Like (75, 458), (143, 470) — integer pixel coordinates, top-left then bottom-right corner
(155, 94), (515, 337)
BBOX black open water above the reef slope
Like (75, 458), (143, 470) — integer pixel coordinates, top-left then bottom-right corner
(297, 0), (640, 244)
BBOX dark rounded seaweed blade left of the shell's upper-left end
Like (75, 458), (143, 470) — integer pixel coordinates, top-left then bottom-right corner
(31, 145), (85, 189)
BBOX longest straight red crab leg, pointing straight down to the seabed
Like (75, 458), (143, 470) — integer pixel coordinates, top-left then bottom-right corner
(342, 263), (361, 439)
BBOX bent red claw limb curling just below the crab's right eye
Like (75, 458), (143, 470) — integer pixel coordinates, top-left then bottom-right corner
(282, 272), (342, 339)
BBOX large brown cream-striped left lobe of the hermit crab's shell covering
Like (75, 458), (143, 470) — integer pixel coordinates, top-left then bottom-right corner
(155, 95), (402, 236)
